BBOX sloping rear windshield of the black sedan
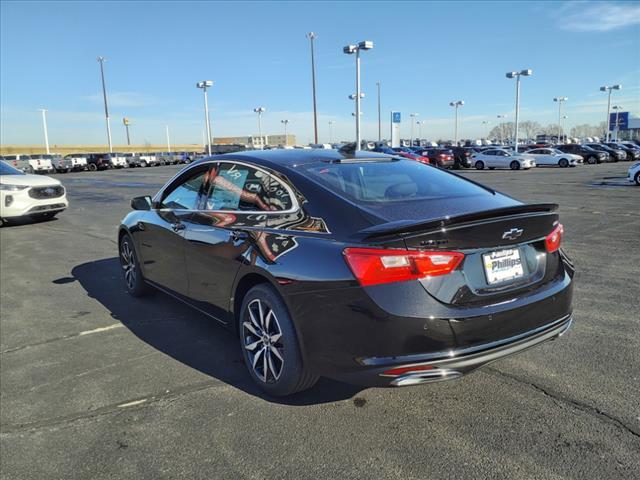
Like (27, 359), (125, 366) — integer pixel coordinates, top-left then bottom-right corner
(306, 160), (491, 203)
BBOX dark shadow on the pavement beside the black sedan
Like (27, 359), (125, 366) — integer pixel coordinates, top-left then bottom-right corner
(68, 257), (362, 405)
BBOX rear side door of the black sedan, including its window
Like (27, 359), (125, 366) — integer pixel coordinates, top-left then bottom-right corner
(185, 160), (292, 321)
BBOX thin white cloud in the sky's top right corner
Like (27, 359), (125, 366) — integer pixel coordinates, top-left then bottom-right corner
(555, 2), (640, 32)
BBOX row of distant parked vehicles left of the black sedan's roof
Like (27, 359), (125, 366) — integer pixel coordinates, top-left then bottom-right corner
(0, 152), (203, 174)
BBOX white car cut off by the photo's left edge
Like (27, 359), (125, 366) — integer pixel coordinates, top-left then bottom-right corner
(0, 162), (69, 223)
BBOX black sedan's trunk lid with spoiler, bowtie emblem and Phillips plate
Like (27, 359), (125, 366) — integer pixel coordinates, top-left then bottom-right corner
(361, 204), (562, 307)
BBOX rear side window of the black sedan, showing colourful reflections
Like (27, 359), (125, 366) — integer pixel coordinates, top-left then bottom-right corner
(205, 162), (293, 212)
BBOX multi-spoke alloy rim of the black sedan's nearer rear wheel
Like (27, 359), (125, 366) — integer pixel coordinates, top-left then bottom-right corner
(242, 299), (284, 383)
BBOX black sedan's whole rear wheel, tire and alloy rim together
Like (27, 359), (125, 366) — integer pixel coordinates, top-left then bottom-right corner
(238, 284), (319, 397)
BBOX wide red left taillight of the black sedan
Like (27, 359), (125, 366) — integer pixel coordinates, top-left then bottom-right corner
(344, 248), (464, 286)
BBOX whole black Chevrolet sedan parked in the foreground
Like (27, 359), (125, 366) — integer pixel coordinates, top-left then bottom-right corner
(118, 150), (574, 395)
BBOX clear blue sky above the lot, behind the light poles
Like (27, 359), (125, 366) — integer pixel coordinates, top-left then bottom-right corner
(0, 1), (640, 144)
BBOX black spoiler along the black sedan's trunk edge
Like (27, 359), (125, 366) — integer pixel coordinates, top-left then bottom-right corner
(358, 203), (558, 240)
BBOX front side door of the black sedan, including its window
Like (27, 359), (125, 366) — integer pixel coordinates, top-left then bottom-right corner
(134, 165), (208, 295)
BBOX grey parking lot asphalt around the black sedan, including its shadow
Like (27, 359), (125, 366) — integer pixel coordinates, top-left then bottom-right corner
(0, 162), (640, 479)
